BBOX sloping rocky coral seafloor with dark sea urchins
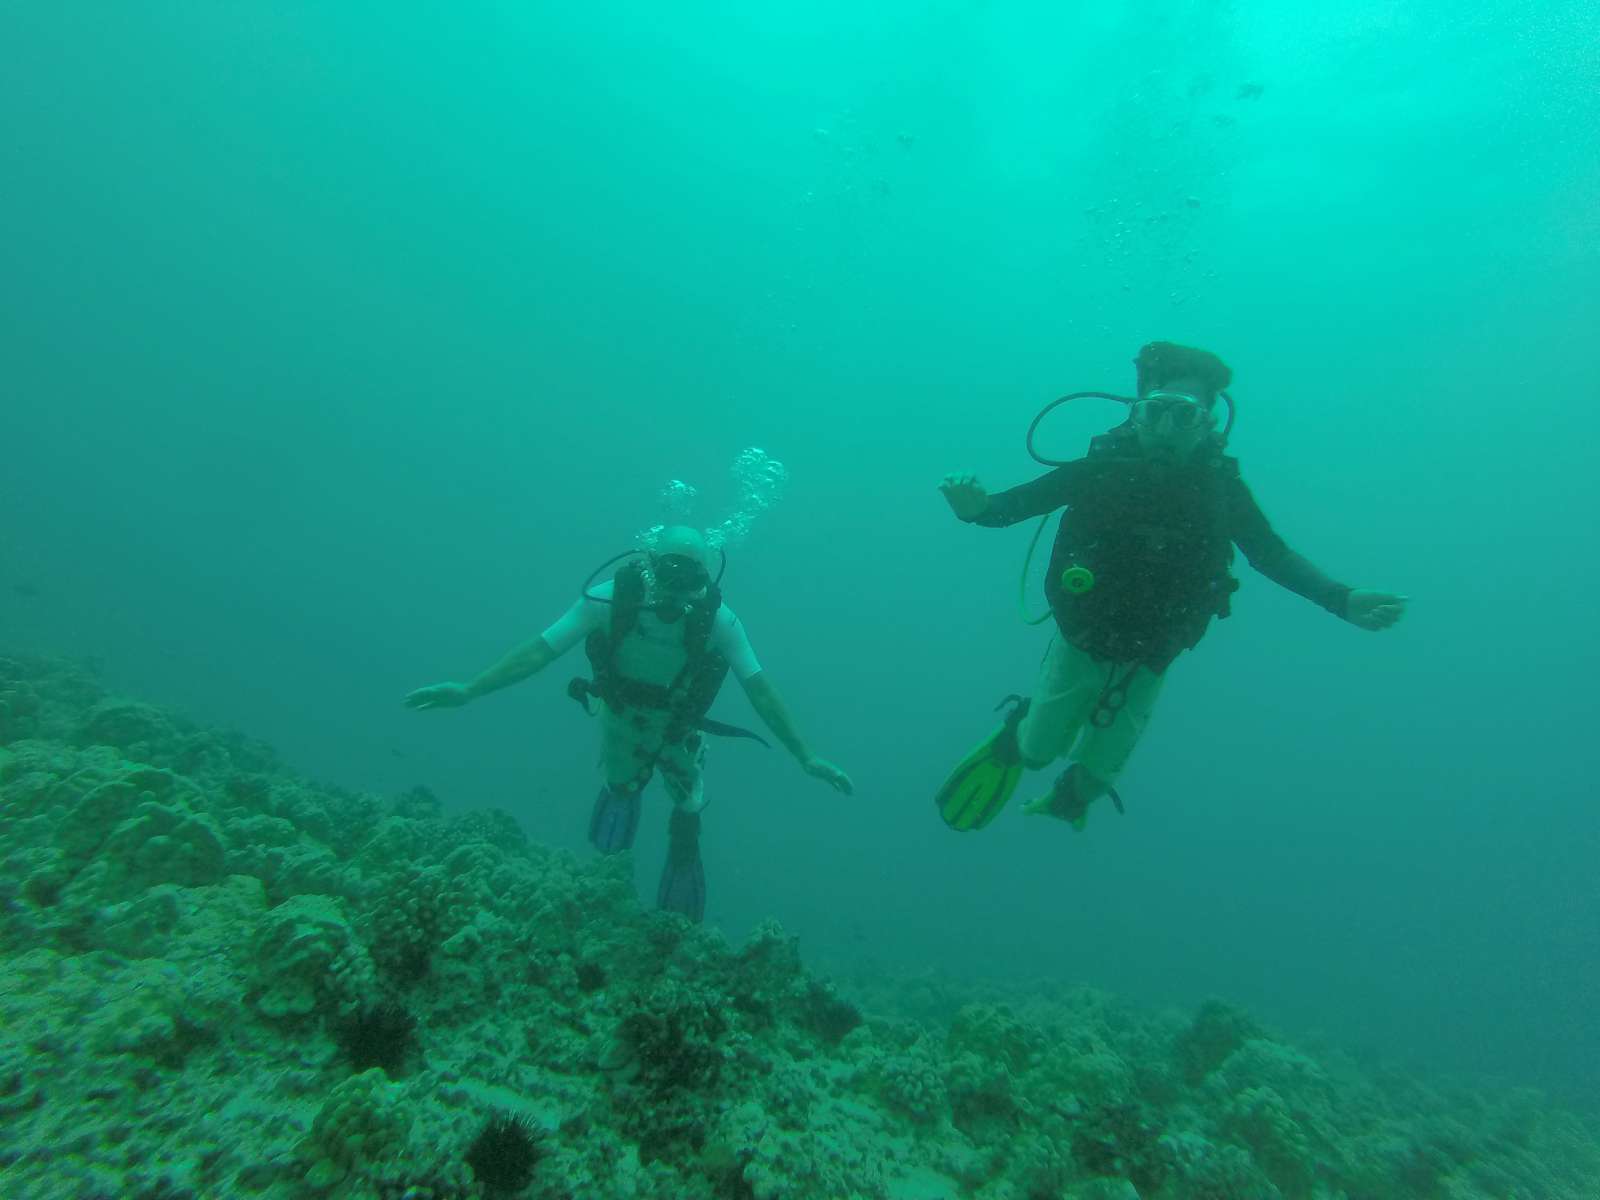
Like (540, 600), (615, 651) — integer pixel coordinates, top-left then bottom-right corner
(0, 656), (1600, 1200)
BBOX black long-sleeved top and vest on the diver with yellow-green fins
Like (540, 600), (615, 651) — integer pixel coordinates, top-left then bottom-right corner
(973, 426), (1350, 670)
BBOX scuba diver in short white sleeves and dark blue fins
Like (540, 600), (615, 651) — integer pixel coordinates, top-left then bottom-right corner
(405, 525), (853, 922)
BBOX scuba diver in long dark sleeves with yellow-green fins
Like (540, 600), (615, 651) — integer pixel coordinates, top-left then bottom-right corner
(934, 342), (1406, 830)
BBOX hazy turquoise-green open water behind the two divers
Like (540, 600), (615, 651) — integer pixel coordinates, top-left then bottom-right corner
(0, 2), (1600, 1098)
